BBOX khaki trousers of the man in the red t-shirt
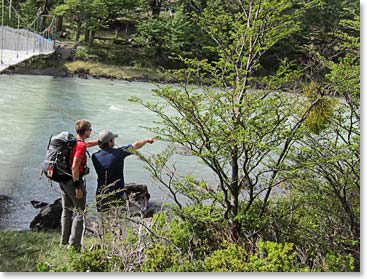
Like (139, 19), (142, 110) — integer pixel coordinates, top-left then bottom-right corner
(60, 179), (87, 250)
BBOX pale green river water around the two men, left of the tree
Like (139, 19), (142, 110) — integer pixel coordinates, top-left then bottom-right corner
(0, 75), (213, 230)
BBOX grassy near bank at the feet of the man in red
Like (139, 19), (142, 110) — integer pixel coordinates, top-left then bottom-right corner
(0, 230), (103, 272)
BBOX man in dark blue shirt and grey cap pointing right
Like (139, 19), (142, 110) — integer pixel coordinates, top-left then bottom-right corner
(92, 131), (154, 212)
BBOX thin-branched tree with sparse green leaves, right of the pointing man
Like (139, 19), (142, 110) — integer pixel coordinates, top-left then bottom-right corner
(135, 0), (319, 240)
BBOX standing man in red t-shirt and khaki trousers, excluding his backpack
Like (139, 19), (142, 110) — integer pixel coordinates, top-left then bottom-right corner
(59, 119), (98, 251)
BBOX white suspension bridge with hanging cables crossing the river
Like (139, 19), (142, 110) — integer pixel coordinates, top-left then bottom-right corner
(0, 0), (56, 73)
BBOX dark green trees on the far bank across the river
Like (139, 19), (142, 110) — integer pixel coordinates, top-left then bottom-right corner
(13, 0), (359, 75)
